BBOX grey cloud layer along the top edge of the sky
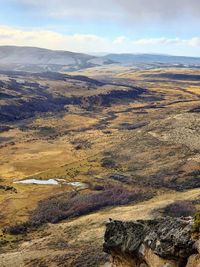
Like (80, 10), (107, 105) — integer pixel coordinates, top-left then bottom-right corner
(7, 0), (200, 22)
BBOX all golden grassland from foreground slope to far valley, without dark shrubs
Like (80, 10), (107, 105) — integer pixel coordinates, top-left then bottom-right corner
(0, 67), (200, 266)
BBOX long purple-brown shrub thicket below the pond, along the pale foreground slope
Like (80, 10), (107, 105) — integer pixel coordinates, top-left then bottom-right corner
(5, 185), (153, 234)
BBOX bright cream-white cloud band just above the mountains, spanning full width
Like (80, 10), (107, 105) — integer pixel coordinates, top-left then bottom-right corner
(0, 26), (200, 55)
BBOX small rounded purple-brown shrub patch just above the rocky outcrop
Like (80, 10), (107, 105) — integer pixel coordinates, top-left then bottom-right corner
(164, 200), (196, 217)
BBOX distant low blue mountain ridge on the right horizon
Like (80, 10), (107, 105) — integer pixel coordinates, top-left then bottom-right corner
(104, 54), (200, 65)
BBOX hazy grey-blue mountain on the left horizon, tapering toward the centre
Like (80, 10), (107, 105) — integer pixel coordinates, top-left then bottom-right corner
(0, 46), (112, 72)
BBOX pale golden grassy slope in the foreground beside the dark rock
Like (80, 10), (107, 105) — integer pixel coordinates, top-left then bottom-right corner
(0, 189), (200, 267)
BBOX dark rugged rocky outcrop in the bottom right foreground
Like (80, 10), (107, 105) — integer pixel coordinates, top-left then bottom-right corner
(103, 217), (200, 267)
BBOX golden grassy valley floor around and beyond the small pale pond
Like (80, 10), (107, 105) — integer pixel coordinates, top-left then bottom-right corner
(0, 69), (200, 224)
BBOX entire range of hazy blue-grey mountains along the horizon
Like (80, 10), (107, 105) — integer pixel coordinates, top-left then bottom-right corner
(0, 46), (200, 72)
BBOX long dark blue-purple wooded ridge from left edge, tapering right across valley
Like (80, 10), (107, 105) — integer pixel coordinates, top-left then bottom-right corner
(0, 73), (147, 123)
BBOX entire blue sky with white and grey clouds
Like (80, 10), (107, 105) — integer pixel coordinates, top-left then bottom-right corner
(0, 0), (200, 57)
